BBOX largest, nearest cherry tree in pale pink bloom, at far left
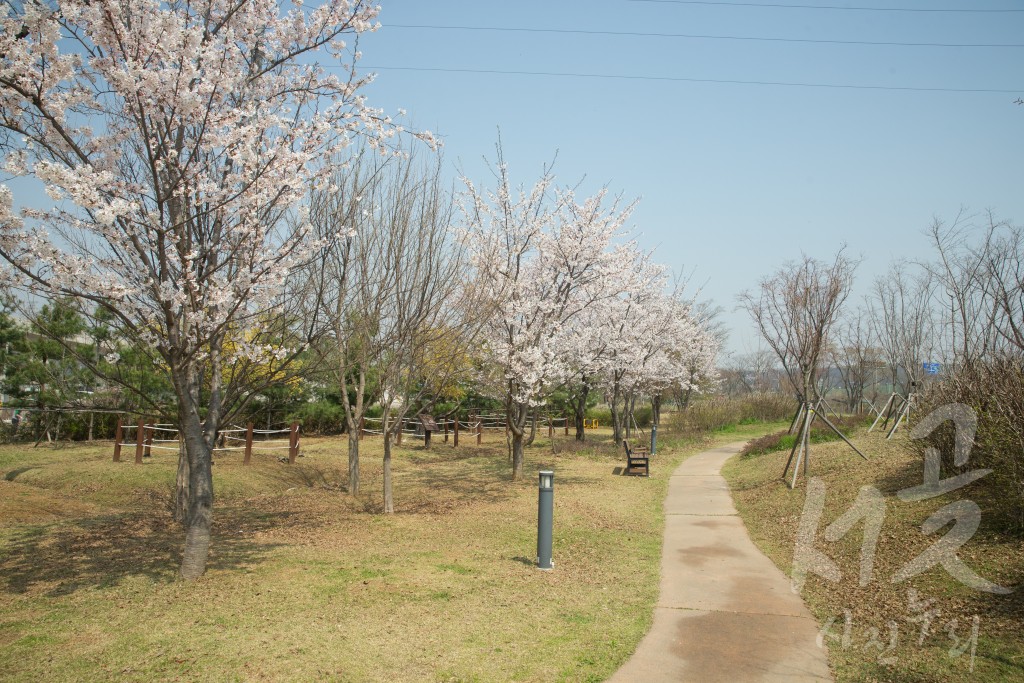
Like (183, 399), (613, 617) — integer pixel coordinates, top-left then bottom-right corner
(0, 0), (423, 580)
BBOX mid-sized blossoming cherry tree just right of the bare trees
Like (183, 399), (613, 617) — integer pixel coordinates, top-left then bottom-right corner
(463, 147), (635, 479)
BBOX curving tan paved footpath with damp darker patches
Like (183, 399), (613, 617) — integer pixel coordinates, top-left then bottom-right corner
(610, 443), (831, 683)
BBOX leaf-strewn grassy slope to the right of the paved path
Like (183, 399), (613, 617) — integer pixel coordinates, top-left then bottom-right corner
(723, 429), (1024, 682)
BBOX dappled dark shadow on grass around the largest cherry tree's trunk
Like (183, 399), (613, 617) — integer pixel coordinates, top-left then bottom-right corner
(0, 509), (310, 597)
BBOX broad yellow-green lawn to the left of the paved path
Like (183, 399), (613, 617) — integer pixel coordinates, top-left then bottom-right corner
(0, 425), (765, 681)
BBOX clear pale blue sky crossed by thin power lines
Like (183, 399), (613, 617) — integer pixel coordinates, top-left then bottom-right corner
(359, 0), (1024, 358)
